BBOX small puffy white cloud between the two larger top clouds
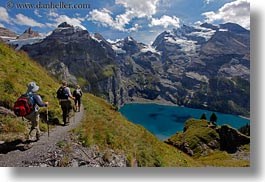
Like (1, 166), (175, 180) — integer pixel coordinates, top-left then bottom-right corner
(149, 15), (180, 28)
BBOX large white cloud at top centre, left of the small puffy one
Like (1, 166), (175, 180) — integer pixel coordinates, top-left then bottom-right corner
(88, 0), (158, 31)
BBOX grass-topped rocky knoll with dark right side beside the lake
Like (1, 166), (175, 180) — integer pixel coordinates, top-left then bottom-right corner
(165, 119), (250, 157)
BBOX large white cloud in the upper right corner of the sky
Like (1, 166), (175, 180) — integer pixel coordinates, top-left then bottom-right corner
(202, 0), (250, 29)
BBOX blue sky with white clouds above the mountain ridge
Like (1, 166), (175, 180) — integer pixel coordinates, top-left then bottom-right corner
(0, 0), (250, 44)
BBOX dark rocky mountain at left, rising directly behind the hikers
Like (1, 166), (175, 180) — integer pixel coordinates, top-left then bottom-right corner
(23, 23), (124, 104)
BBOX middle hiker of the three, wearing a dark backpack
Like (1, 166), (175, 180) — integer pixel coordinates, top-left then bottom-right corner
(57, 81), (75, 126)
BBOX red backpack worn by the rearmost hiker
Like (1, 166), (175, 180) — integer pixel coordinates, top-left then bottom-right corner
(13, 94), (34, 117)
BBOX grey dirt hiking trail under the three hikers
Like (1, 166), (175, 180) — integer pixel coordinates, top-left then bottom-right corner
(0, 107), (84, 167)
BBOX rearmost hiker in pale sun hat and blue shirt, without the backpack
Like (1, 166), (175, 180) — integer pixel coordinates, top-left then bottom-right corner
(25, 82), (48, 141)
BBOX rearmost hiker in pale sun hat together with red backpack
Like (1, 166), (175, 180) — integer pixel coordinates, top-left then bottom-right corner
(14, 82), (48, 141)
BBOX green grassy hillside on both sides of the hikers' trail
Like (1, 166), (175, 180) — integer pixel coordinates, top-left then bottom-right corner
(0, 44), (197, 166)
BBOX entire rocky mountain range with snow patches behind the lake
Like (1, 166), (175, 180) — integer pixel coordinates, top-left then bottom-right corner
(17, 23), (250, 116)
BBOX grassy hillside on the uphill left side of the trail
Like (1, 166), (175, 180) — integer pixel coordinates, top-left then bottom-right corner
(0, 44), (60, 140)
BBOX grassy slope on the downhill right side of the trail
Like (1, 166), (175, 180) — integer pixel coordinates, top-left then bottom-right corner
(72, 95), (199, 167)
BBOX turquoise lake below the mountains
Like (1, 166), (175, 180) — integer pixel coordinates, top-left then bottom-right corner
(119, 103), (250, 140)
